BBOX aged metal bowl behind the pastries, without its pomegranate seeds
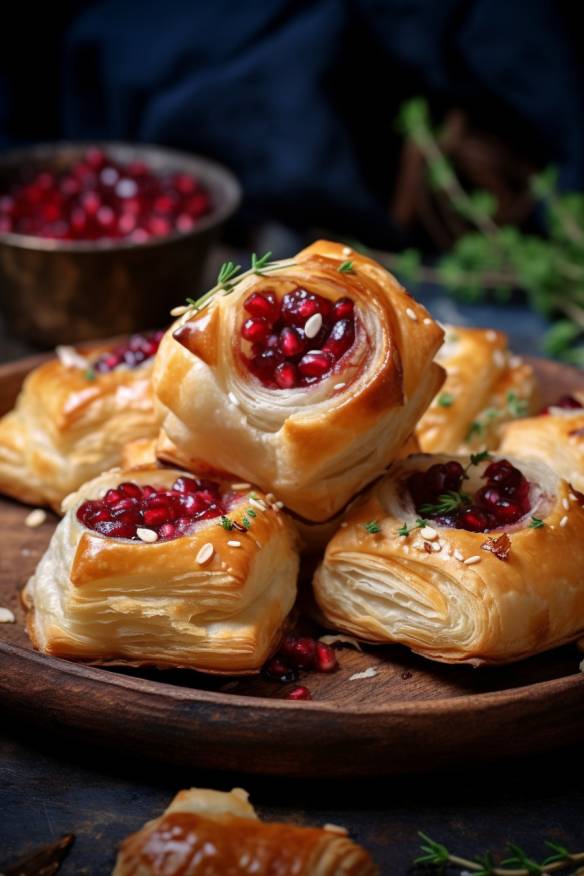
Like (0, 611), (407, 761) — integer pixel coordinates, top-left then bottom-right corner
(0, 142), (241, 346)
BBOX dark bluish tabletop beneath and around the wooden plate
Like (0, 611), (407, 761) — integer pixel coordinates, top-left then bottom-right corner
(0, 255), (584, 876)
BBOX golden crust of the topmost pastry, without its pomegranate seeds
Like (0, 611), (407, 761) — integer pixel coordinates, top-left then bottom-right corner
(153, 241), (443, 522)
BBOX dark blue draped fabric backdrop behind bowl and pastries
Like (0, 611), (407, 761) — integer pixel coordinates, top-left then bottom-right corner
(0, 0), (584, 243)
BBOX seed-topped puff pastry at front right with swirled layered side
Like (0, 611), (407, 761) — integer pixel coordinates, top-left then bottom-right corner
(314, 454), (584, 665)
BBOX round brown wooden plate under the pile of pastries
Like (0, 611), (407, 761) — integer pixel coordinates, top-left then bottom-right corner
(0, 358), (584, 777)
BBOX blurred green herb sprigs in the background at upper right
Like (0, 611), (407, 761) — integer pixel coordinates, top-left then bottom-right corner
(374, 98), (584, 366)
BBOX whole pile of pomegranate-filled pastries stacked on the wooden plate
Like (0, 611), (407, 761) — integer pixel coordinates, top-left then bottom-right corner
(0, 241), (584, 672)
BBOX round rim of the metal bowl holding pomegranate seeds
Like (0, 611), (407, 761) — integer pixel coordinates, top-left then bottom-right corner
(0, 139), (242, 253)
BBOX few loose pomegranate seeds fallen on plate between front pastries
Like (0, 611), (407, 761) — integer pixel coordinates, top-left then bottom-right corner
(264, 635), (339, 700)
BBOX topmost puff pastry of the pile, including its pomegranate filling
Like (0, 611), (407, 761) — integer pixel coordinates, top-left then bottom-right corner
(153, 241), (443, 522)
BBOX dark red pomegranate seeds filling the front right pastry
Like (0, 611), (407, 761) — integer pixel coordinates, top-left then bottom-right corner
(407, 459), (531, 532)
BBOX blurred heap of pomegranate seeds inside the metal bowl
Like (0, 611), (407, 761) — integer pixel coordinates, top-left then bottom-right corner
(0, 148), (212, 243)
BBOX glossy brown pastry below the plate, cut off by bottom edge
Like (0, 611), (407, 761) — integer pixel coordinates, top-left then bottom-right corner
(112, 788), (379, 876)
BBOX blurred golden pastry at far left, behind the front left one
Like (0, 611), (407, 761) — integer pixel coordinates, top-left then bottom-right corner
(0, 333), (162, 511)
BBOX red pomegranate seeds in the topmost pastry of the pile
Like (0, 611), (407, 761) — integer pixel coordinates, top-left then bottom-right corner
(241, 288), (355, 389)
